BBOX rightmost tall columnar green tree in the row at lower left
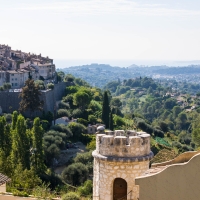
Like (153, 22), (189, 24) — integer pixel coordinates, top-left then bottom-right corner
(31, 117), (45, 173)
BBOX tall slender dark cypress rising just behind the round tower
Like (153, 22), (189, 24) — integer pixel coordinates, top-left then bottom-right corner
(102, 91), (110, 128)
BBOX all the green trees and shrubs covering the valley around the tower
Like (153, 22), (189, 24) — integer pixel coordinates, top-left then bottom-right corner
(0, 72), (200, 199)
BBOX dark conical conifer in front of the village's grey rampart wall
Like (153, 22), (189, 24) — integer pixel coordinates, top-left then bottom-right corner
(19, 79), (44, 116)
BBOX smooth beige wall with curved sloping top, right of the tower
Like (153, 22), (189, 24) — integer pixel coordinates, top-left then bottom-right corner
(135, 154), (200, 200)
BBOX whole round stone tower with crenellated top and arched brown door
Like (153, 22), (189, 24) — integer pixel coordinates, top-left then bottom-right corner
(92, 130), (153, 200)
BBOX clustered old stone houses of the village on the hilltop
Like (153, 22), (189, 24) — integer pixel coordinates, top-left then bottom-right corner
(0, 45), (55, 89)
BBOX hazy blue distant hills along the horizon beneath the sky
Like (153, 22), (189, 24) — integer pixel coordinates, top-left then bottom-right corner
(58, 63), (200, 88)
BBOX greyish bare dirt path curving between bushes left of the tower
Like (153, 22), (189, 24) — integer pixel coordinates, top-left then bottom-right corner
(54, 142), (86, 174)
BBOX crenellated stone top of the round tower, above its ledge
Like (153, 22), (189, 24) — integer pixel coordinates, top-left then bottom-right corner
(96, 130), (151, 157)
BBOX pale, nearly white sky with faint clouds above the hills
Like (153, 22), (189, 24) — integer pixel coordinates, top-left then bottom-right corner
(0, 0), (200, 66)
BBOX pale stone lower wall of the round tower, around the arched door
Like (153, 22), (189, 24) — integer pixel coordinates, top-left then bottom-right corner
(93, 158), (149, 200)
